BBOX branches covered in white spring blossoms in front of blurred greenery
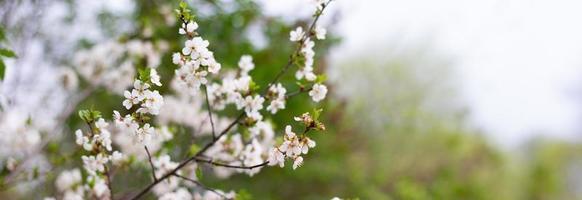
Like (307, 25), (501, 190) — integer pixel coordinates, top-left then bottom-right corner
(0, 0), (331, 199)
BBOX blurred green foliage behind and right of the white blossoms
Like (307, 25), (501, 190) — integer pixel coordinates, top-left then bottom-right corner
(0, 0), (582, 200)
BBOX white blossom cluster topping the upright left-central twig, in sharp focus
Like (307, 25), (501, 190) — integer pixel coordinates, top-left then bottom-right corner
(172, 21), (221, 94)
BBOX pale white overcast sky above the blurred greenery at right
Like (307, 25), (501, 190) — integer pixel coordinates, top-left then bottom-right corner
(265, 0), (582, 148)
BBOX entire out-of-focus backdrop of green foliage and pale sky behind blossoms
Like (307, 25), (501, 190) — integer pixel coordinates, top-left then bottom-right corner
(0, 0), (582, 199)
